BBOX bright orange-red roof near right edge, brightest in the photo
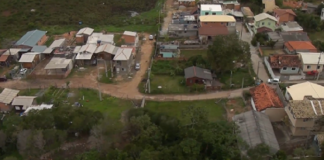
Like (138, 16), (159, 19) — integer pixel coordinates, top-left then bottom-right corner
(285, 41), (317, 52)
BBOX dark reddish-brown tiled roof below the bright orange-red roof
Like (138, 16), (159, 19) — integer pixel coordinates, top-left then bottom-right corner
(269, 54), (301, 69)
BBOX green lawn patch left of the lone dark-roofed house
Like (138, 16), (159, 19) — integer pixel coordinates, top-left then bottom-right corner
(146, 75), (189, 94)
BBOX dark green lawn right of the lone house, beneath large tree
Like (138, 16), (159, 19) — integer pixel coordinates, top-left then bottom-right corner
(218, 68), (254, 89)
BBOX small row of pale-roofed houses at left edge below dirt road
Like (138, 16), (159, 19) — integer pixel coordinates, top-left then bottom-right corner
(0, 88), (54, 115)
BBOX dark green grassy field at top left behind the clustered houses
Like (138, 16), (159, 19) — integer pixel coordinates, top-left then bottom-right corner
(0, 0), (163, 42)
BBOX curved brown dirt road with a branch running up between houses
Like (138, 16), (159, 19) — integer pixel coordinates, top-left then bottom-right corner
(0, 34), (248, 101)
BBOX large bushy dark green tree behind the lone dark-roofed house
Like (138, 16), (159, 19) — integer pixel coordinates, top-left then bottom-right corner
(207, 34), (250, 73)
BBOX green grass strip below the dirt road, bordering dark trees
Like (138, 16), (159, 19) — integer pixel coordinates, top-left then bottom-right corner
(145, 100), (225, 122)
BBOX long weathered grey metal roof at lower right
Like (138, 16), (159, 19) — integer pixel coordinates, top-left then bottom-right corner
(233, 110), (280, 153)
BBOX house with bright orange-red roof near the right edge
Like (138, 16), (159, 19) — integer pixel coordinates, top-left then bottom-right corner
(284, 41), (317, 54)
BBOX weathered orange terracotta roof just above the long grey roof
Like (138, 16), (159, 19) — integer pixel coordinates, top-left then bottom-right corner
(250, 83), (284, 111)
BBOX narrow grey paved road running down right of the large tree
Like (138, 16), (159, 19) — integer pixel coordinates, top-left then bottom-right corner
(236, 22), (269, 82)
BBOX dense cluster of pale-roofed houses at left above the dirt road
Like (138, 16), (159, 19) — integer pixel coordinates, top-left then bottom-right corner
(0, 27), (139, 77)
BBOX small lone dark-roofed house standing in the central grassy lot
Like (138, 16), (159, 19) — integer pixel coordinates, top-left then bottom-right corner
(184, 66), (213, 86)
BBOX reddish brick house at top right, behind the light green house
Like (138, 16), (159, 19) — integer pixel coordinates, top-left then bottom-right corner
(273, 8), (297, 23)
